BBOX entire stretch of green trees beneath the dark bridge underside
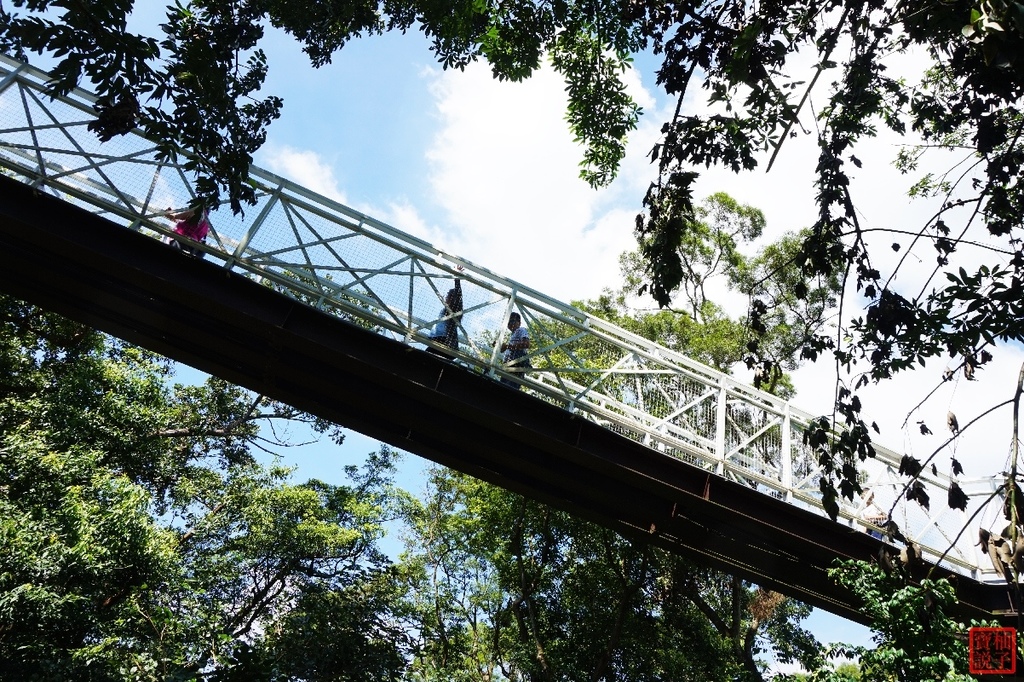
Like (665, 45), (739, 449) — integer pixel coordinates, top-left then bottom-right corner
(0, 280), (839, 682)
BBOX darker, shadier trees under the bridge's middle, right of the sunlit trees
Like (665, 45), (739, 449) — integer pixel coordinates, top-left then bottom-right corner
(406, 454), (820, 682)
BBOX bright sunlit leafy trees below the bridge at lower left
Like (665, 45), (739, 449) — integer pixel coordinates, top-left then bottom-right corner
(0, 297), (409, 682)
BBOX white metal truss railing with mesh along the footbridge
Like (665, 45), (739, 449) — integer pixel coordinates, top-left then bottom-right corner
(0, 56), (999, 580)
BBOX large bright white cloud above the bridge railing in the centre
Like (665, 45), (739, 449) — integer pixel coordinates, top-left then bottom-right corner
(427, 60), (667, 300)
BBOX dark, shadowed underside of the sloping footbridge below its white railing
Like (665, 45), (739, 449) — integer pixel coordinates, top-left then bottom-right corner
(0, 177), (1016, 624)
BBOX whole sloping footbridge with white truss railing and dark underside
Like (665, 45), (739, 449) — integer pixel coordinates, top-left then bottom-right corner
(0, 56), (1017, 621)
